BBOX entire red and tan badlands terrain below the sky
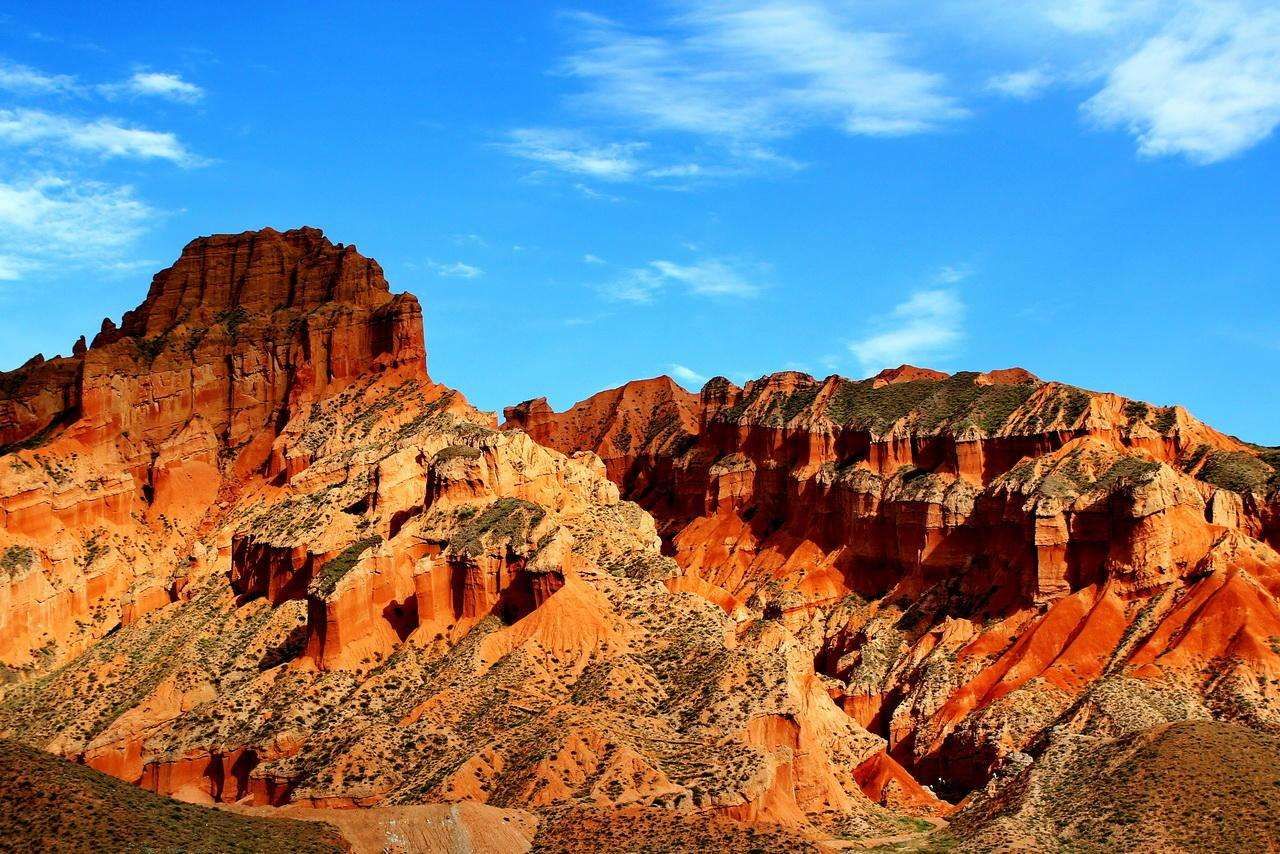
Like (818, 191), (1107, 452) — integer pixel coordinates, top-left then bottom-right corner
(0, 228), (1280, 851)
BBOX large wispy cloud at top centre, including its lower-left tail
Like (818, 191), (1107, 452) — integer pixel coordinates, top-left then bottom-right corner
(506, 0), (968, 184)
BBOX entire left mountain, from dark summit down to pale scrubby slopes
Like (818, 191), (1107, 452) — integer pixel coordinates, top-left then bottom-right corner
(0, 229), (946, 845)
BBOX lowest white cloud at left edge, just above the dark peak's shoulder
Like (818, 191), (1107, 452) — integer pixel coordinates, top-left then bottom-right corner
(0, 175), (157, 279)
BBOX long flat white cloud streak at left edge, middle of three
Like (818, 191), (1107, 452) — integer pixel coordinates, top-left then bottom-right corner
(0, 109), (200, 165)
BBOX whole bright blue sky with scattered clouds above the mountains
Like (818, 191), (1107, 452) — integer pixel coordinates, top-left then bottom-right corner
(0, 0), (1280, 443)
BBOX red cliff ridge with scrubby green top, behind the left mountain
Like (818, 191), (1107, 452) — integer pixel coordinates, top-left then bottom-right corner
(506, 366), (1280, 795)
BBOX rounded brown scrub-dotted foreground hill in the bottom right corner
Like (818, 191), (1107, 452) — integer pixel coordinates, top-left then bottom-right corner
(947, 721), (1280, 851)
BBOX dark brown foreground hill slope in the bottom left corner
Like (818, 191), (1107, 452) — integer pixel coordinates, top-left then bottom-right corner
(0, 740), (349, 854)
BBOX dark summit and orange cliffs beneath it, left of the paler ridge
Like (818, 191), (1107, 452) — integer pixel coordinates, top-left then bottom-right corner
(0, 228), (426, 668)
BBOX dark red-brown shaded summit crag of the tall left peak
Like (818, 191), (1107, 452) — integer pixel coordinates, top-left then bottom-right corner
(0, 228), (426, 447)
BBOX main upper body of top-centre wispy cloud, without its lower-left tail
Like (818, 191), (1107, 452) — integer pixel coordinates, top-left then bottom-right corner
(562, 1), (966, 141)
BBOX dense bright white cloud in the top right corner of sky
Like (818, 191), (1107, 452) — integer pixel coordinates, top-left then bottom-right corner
(1082, 3), (1280, 164)
